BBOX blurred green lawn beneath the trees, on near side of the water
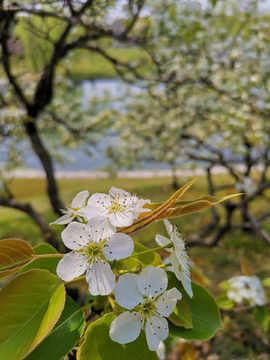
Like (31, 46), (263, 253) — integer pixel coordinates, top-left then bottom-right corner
(0, 175), (270, 360)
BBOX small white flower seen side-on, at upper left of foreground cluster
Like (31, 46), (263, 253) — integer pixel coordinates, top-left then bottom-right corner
(50, 190), (89, 225)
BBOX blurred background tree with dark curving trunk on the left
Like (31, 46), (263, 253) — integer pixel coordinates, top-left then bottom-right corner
(0, 0), (148, 246)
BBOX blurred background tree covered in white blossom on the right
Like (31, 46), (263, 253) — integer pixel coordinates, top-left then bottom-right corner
(103, 3), (270, 246)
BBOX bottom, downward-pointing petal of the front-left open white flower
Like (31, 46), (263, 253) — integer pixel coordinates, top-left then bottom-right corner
(86, 260), (115, 295)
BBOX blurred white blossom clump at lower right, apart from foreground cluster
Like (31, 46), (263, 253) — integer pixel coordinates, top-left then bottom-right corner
(227, 276), (267, 306)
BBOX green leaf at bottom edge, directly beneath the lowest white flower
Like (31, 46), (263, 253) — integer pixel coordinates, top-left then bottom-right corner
(77, 313), (158, 360)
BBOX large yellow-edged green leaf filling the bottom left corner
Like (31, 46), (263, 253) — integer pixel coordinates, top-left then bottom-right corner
(0, 269), (65, 360)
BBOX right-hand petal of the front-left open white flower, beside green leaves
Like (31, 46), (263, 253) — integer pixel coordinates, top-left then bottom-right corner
(103, 233), (134, 261)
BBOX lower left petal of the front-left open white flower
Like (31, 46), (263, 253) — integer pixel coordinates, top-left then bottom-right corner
(56, 252), (87, 281)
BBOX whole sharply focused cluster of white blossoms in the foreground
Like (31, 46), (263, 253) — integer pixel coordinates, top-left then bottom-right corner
(52, 187), (193, 351)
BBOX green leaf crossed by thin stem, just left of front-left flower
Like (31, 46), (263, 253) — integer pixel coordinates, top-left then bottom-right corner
(20, 244), (63, 275)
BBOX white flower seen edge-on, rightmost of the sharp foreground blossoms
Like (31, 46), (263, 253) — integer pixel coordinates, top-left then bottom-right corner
(156, 220), (193, 297)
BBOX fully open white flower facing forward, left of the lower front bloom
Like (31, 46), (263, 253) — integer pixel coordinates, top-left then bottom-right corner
(56, 216), (134, 295)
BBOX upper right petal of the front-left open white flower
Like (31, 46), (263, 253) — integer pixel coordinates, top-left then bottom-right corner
(87, 216), (116, 242)
